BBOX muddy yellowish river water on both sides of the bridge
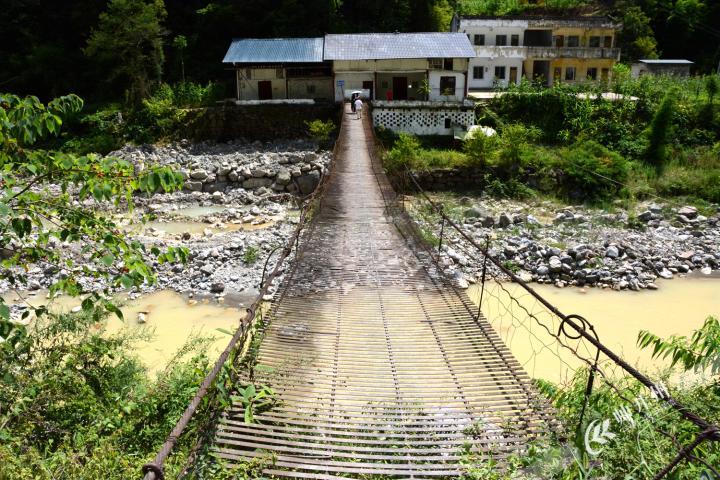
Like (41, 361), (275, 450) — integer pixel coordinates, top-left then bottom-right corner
(6, 278), (720, 383)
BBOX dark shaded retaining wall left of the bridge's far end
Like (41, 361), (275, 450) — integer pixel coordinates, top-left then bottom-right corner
(179, 103), (340, 141)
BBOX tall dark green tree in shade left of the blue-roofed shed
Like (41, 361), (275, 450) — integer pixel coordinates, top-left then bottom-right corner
(85, 0), (167, 104)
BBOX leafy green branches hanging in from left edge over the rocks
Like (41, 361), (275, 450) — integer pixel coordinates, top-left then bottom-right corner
(0, 94), (186, 348)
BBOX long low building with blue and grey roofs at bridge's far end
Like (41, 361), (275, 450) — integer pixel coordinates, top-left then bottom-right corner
(224, 32), (476, 135)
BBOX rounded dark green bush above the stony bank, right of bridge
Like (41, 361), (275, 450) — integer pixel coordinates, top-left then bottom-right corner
(553, 141), (630, 201)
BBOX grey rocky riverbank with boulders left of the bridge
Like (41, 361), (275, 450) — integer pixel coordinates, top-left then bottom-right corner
(0, 141), (331, 312)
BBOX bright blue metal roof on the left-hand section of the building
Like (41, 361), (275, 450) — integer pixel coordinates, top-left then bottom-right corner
(223, 38), (323, 63)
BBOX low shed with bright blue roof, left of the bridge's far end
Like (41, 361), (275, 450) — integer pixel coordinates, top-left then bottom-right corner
(223, 37), (333, 100)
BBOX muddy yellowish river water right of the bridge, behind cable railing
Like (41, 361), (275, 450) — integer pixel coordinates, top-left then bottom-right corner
(469, 278), (720, 383)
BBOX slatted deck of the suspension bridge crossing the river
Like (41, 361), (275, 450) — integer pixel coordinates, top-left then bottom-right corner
(213, 107), (548, 479)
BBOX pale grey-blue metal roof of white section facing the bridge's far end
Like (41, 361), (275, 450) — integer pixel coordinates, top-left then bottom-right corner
(325, 32), (475, 60)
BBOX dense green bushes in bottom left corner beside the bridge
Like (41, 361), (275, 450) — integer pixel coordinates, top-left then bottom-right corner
(0, 312), (208, 480)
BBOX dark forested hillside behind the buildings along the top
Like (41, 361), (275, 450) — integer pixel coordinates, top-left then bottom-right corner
(0, 0), (720, 100)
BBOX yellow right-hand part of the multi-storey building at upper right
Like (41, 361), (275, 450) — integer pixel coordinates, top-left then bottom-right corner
(523, 17), (620, 86)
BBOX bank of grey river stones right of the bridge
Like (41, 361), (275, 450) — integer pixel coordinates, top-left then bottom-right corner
(415, 195), (720, 290)
